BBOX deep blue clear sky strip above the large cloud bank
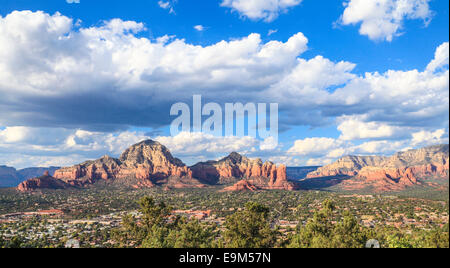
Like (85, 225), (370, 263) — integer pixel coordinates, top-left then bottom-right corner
(0, 0), (449, 73)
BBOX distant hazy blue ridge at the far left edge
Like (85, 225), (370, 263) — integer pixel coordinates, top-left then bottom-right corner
(0, 166), (60, 187)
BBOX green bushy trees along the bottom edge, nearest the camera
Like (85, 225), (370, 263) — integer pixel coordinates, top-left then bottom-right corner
(108, 198), (449, 248)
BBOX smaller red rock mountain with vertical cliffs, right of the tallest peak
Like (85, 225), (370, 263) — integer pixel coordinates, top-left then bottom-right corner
(191, 153), (295, 190)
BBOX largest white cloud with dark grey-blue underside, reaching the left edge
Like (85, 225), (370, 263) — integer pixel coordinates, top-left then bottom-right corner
(0, 11), (308, 131)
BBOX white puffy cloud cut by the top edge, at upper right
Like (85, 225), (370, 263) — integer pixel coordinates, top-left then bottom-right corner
(340, 0), (432, 41)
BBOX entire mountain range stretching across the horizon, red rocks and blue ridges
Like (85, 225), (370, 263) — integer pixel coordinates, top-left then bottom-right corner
(7, 140), (449, 193)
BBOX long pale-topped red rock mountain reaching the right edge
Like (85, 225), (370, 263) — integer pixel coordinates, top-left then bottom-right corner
(307, 145), (449, 192)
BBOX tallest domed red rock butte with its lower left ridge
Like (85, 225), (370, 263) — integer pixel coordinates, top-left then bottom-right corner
(51, 140), (203, 188)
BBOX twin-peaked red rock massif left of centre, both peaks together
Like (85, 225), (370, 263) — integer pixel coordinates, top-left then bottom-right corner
(18, 140), (293, 191)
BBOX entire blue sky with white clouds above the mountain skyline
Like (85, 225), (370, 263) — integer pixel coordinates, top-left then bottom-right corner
(0, 0), (449, 168)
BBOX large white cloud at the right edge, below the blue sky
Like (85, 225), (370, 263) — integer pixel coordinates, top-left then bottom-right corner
(324, 57), (449, 130)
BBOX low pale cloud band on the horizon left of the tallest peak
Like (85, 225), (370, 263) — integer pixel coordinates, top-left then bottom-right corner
(0, 127), (149, 168)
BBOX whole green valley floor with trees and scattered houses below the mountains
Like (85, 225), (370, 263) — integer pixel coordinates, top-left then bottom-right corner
(0, 189), (449, 248)
